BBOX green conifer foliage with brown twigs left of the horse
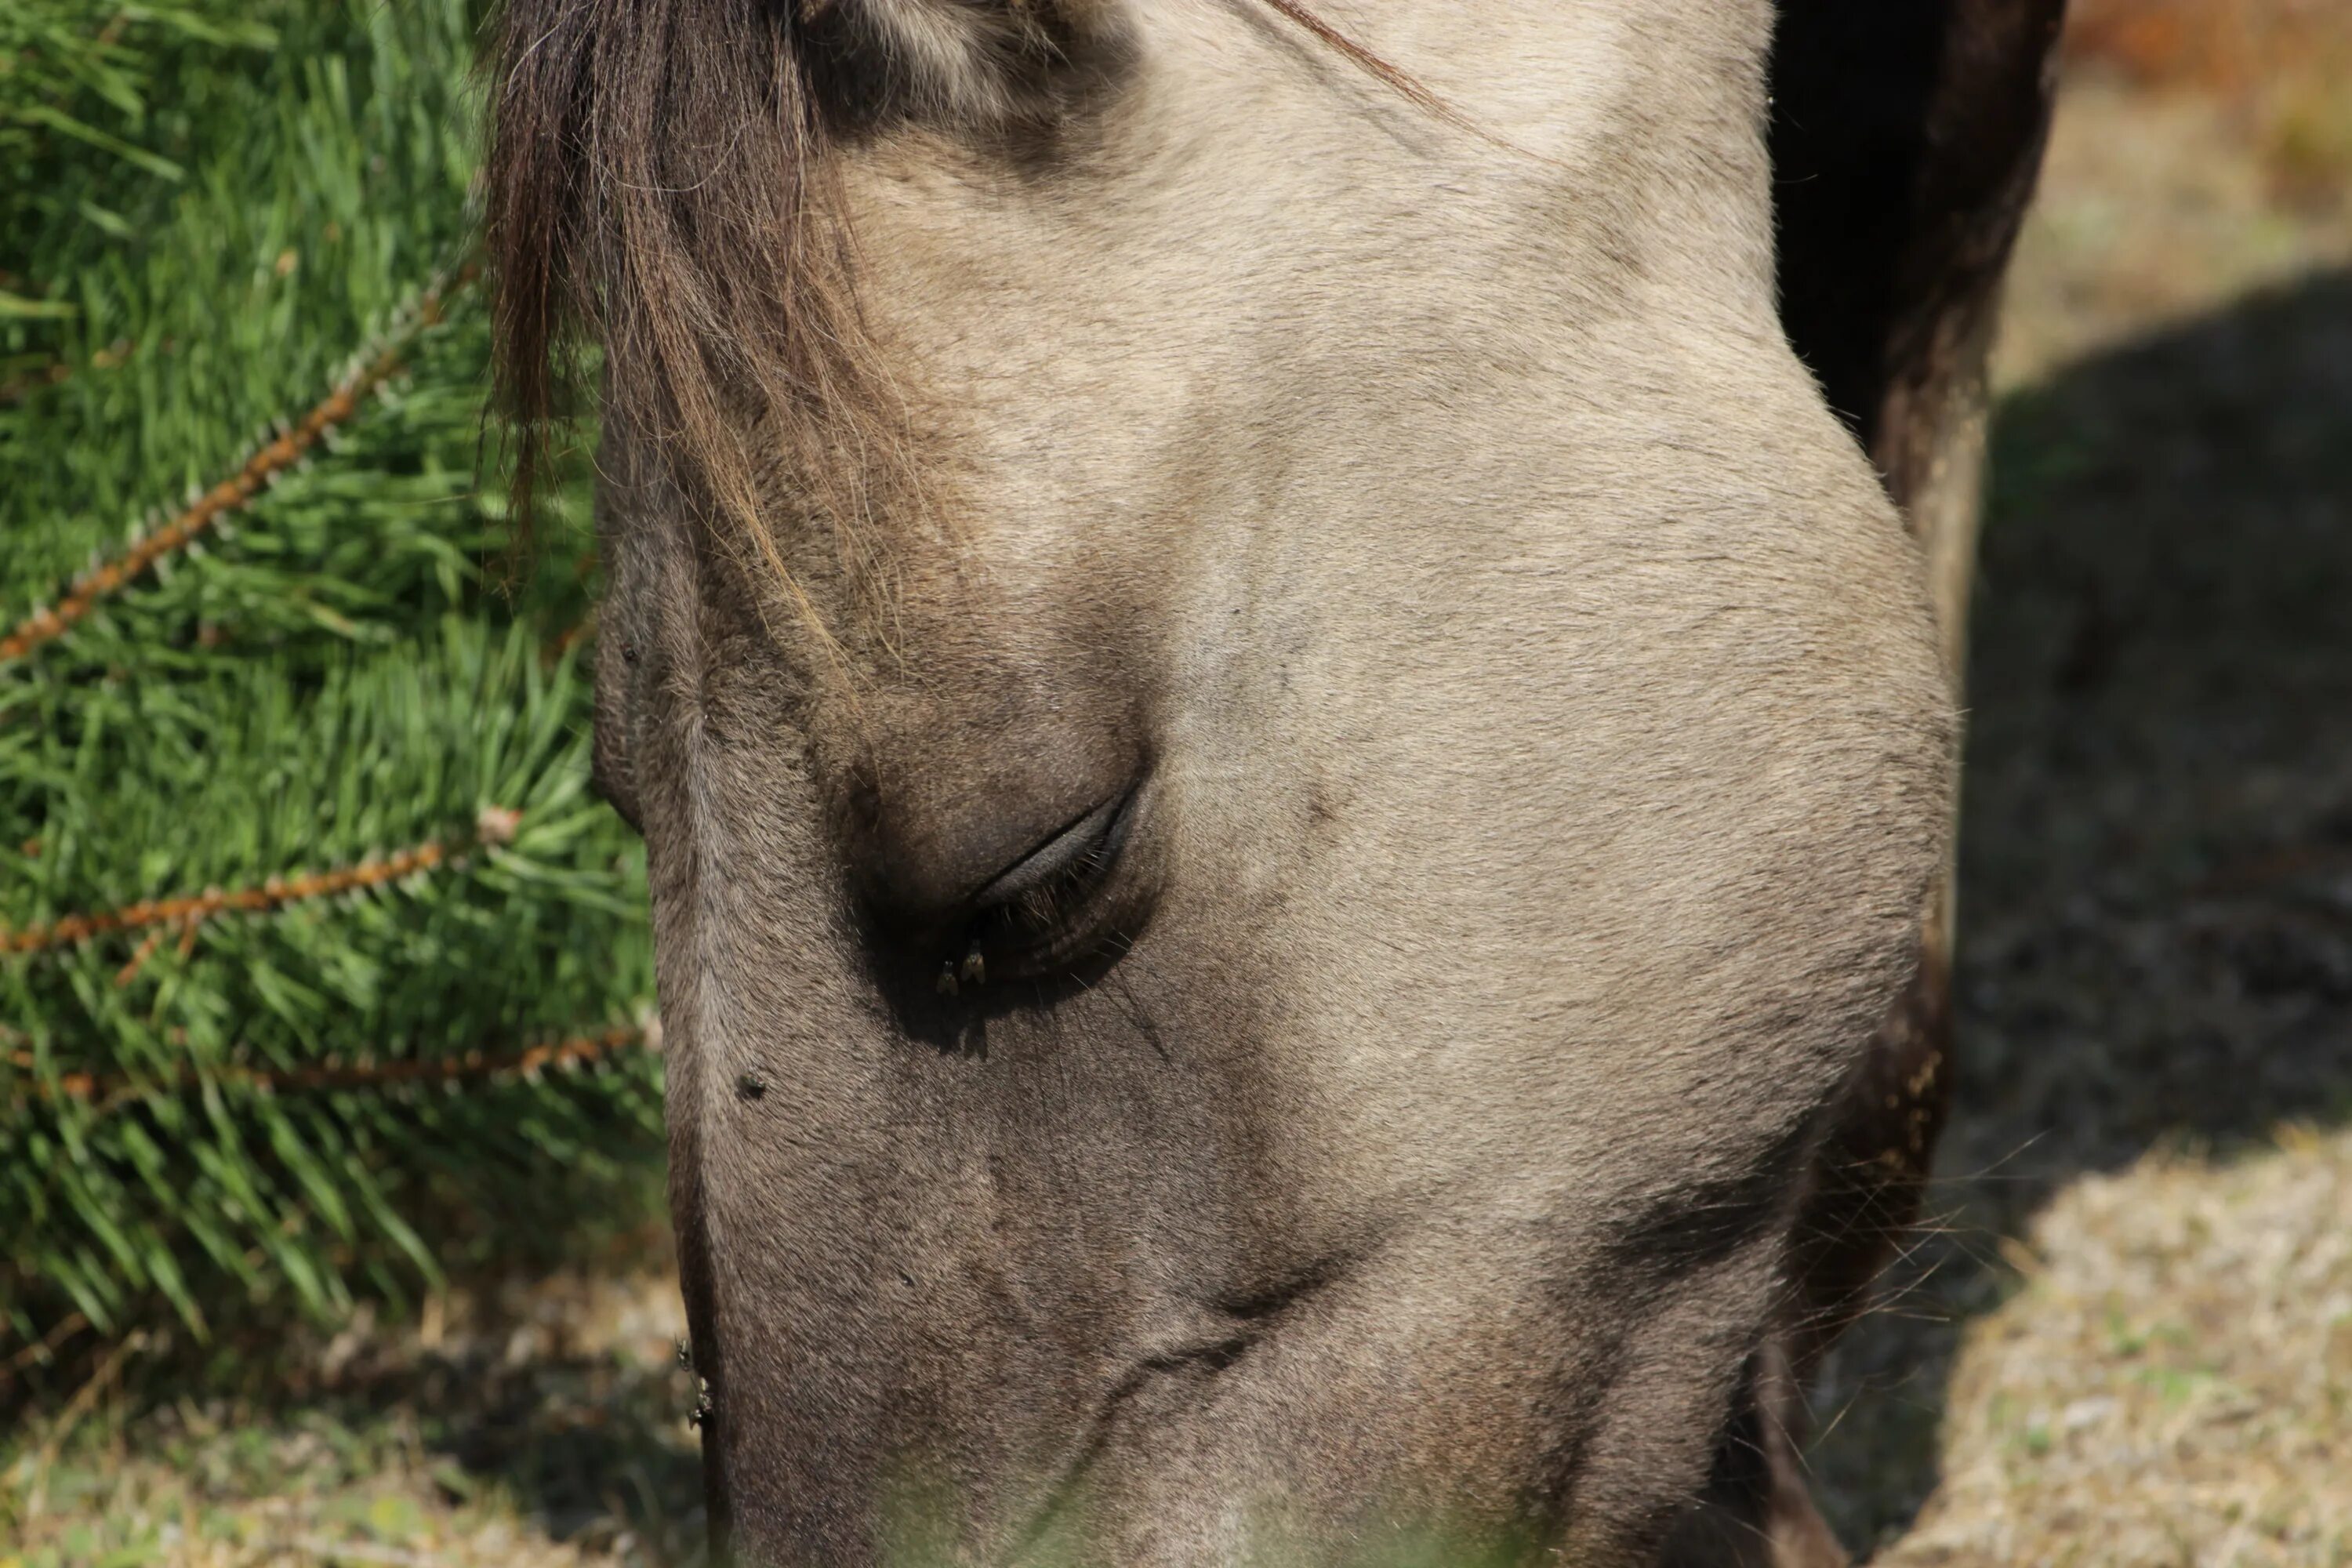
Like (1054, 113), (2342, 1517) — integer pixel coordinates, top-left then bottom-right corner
(0, 0), (661, 1345)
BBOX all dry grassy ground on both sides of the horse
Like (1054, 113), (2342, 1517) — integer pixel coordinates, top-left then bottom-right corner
(0, 0), (2352, 1568)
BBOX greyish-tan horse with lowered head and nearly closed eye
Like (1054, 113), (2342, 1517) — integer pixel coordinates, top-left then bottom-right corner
(489, 0), (2058, 1566)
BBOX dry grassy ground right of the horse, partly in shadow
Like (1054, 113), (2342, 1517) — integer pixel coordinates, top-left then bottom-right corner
(1811, 0), (2352, 1568)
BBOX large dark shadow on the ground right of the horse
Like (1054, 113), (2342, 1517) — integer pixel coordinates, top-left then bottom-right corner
(1813, 273), (2352, 1547)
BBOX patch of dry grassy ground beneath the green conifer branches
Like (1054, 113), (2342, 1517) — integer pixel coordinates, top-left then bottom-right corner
(0, 1243), (706, 1568)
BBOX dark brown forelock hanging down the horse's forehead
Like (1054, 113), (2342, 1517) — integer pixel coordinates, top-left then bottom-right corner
(487, 0), (877, 554)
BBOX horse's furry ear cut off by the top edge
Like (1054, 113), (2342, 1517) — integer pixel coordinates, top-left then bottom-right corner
(800, 0), (1129, 127)
